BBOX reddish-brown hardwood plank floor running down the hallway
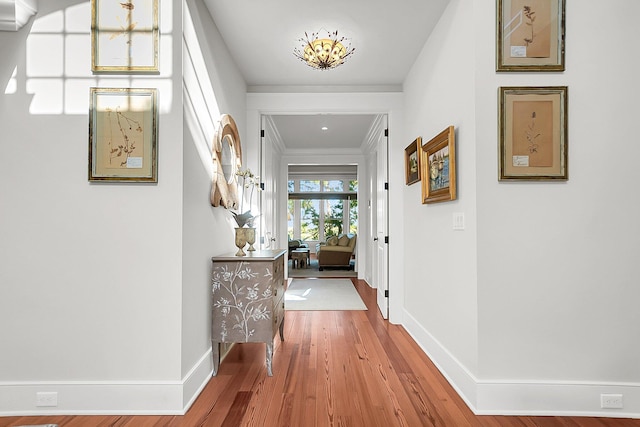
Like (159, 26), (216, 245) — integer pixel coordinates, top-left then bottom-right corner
(0, 279), (640, 427)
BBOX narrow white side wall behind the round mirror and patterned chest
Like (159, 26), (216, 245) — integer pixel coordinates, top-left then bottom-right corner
(182, 0), (251, 406)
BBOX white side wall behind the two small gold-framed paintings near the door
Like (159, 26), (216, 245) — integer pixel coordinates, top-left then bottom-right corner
(402, 0), (478, 398)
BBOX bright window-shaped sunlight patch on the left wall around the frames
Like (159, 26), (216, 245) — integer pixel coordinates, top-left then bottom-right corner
(19, 1), (173, 115)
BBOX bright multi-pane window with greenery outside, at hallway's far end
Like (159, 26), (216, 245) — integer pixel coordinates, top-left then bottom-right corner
(287, 178), (358, 241)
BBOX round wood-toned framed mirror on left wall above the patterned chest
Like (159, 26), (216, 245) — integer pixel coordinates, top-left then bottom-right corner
(211, 114), (242, 209)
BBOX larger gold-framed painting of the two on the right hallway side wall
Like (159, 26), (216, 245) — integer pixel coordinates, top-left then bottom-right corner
(420, 126), (457, 204)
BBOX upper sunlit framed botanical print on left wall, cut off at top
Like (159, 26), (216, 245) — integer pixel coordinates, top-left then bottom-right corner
(91, 0), (160, 74)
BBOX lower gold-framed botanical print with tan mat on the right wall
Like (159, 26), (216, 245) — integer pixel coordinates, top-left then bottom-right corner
(498, 86), (569, 180)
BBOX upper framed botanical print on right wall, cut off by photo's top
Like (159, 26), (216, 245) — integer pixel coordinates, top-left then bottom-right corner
(496, 0), (565, 71)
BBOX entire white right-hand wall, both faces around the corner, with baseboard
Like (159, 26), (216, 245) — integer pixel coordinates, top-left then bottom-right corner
(405, 0), (640, 417)
